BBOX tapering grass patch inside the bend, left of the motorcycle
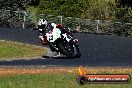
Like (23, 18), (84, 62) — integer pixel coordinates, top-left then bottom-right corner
(0, 41), (46, 60)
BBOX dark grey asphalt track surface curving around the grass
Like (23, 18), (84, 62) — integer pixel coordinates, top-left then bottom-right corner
(0, 27), (132, 67)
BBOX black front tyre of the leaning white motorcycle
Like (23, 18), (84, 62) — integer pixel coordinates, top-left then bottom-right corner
(58, 42), (74, 58)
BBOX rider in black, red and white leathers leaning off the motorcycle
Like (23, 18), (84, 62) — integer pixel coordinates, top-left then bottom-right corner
(38, 19), (81, 57)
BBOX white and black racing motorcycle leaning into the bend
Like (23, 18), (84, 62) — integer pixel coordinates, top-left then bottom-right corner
(46, 26), (80, 58)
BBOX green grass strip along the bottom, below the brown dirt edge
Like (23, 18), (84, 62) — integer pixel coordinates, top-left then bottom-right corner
(0, 68), (132, 88)
